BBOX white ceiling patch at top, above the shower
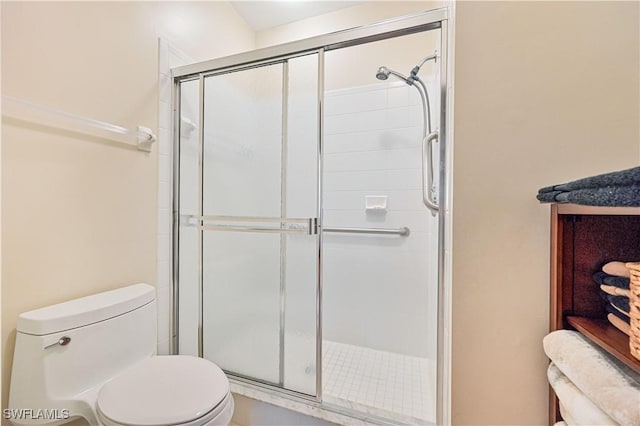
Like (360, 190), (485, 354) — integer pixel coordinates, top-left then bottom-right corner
(230, 0), (362, 31)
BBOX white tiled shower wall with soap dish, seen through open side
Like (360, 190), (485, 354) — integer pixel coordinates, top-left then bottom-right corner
(323, 82), (437, 358)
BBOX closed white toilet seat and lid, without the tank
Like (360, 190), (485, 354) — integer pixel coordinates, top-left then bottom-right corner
(96, 355), (233, 426)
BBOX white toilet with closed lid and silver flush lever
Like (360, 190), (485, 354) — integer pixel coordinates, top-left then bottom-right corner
(8, 284), (234, 426)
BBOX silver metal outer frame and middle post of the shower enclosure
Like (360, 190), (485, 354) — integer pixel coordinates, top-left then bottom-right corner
(171, 8), (450, 424)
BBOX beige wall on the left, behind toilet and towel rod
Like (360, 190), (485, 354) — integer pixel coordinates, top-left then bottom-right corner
(2, 2), (254, 408)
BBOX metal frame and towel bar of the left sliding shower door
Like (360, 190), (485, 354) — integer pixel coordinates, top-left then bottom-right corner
(171, 55), (324, 402)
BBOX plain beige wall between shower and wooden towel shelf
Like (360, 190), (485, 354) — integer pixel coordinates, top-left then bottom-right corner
(452, 2), (640, 425)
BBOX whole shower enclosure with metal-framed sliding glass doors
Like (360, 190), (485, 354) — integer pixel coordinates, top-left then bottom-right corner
(172, 10), (447, 424)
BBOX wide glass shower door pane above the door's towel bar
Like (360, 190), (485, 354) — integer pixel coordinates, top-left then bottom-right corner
(203, 64), (283, 217)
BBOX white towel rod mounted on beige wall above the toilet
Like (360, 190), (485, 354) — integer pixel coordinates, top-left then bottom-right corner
(2, 95), (156, 152)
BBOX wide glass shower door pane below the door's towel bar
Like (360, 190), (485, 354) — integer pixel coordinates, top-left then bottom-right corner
(203, 231), (280, 384)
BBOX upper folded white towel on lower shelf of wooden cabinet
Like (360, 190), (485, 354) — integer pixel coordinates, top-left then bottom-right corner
(543, 330), (640, 426)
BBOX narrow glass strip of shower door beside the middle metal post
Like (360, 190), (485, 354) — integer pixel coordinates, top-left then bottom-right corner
(282, 55), (318, 395)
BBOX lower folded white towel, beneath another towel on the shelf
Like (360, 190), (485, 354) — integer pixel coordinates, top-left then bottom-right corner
(547, 363), (617, 426)
